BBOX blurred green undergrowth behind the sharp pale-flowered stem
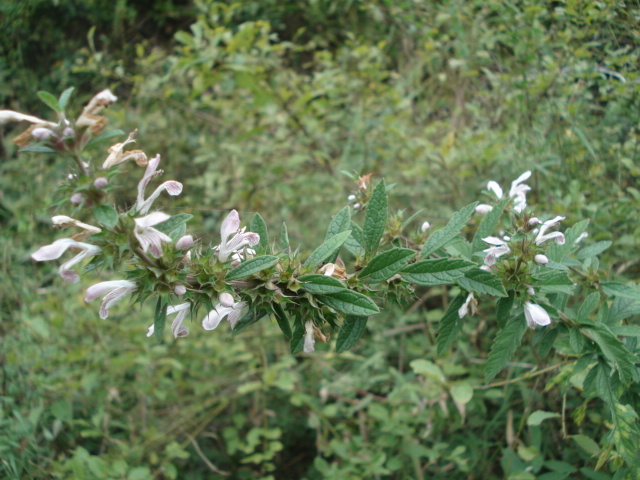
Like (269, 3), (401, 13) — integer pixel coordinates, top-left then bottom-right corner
(0, 0), (640, 480)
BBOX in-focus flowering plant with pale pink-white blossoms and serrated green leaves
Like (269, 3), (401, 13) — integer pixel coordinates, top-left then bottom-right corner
(8, 89), (640, 475)
